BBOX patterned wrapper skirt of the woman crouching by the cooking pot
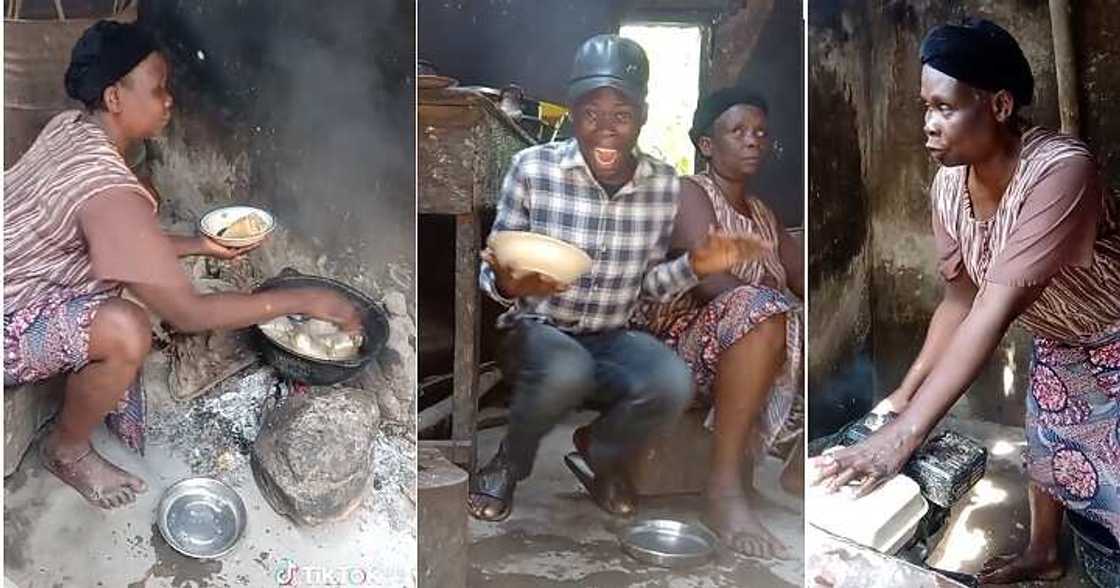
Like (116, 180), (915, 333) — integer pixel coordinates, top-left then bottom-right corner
(3, 289), (144, 454)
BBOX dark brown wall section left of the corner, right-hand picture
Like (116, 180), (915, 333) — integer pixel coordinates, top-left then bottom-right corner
(809, 4), (872, 437)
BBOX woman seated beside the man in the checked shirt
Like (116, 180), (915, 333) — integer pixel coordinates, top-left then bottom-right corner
(635, 88), (803, 557)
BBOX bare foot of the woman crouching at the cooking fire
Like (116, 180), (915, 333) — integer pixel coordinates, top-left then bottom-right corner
(39, 435), (148, 510)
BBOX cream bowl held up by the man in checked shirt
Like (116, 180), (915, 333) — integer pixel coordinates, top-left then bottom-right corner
(488, 231), (591, 283)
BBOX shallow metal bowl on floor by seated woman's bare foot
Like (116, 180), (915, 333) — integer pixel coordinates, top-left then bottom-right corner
(618, 519), (716, 568)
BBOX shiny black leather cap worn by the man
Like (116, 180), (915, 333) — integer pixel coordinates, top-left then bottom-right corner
(568, 35), (650, 104)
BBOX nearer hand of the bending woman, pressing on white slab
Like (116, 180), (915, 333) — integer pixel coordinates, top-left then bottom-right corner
(806, 421), (921, 496)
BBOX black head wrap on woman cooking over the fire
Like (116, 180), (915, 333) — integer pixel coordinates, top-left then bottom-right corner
(65, 20), (158, 108)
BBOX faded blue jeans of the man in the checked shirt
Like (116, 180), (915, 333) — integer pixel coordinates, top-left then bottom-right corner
(501, 319), (692, 480)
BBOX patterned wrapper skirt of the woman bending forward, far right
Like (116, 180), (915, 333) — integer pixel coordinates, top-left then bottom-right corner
(1026, 326), (1120, 540)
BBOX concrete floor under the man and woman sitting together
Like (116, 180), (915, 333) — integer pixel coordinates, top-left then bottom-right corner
(468, 413), (804, 588)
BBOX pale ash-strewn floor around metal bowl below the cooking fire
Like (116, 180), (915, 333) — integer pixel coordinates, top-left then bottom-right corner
(3, 360), (417, 588)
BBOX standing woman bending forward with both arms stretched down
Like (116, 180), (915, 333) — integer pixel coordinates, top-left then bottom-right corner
(812, 19), (1120, 584)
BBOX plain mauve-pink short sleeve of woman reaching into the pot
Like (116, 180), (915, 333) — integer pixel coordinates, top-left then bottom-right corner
(80, 189), (187, 286)
